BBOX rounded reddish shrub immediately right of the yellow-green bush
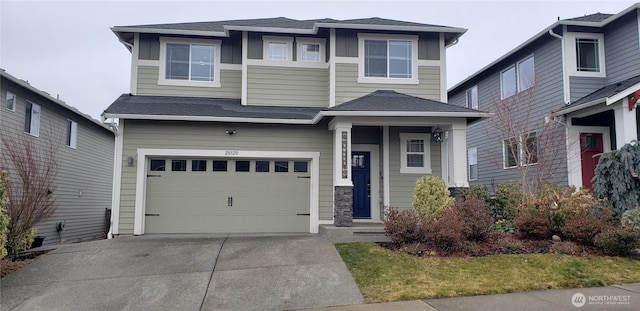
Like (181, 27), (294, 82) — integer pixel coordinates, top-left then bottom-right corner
(456, 197), (493, 241)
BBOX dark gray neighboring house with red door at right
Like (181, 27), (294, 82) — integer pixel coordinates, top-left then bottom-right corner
(448, 4), (640, 193)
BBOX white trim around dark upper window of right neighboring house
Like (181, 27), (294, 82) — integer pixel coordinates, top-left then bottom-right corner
(564, 32), (607, 78)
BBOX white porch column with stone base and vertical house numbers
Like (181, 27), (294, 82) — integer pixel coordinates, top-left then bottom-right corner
(329, 118), (353, 227)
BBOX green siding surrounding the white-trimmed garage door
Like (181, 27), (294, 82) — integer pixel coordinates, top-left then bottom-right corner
(118, 120), (333, 234)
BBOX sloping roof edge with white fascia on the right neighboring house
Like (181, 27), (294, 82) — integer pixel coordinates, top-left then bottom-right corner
(447, 3), (640, 93)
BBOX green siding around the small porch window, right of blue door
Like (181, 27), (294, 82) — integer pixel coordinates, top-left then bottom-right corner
(389, 127), (442, 209)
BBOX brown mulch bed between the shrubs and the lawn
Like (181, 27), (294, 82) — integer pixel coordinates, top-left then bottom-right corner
(378, 232), (612, 258)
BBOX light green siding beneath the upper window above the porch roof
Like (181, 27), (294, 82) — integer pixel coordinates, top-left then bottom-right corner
(336, 63), (441, 105)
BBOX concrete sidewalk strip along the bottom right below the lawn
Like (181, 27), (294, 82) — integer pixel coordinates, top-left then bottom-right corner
(302, 283), (640, 311)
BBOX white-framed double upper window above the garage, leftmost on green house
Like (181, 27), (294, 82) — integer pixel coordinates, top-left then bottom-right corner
(159, 38), (220, 86)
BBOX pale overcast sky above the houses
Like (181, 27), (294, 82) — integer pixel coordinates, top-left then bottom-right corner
(0, 0), (635, 119)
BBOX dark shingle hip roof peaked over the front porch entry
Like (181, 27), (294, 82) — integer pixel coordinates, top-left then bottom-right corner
(327, 90), (478, 112)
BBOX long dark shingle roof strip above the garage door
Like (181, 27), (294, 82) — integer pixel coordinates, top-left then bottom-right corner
(104, 94), (322, 120)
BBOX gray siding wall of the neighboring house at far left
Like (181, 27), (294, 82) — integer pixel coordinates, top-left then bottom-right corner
(0, 79), (114, 244)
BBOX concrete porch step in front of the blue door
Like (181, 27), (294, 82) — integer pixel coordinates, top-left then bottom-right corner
(318, 223), (389, 243)
